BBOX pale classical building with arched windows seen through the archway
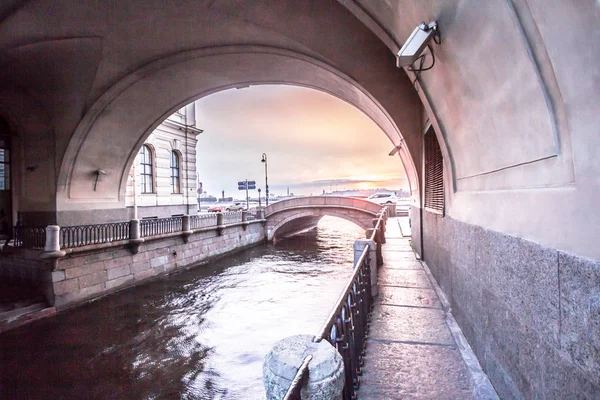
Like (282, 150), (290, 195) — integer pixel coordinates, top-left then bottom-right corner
(126, 103), (202, 219)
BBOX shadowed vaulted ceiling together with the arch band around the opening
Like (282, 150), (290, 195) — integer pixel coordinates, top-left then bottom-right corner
(0, 0), (421, 217)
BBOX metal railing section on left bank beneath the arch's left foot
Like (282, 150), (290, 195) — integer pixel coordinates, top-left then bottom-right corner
(60, 221), (130, 249)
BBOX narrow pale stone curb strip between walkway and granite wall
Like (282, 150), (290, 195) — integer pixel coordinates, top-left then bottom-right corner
(419, 260), (499, 400)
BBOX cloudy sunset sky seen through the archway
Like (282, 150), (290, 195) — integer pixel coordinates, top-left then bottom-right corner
(196, 85), (408, 198)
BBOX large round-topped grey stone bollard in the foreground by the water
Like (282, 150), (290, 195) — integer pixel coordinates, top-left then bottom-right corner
(263, 335), (344, 400)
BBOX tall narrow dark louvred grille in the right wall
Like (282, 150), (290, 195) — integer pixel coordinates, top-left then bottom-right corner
(424, 128), (444, 214)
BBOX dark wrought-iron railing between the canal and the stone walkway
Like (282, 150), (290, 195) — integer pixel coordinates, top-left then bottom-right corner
(284, 210), (386, 400)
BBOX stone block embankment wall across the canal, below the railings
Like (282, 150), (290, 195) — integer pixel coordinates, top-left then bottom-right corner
(51, 221), (265, 308)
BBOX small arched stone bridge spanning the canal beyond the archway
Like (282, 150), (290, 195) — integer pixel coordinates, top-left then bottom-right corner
(265, 196), (381, 241)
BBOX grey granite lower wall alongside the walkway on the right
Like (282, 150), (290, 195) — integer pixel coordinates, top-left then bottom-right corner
(412, 208), (600, 399)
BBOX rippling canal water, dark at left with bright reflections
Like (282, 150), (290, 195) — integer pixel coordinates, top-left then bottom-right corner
(0, 217), (364, 399)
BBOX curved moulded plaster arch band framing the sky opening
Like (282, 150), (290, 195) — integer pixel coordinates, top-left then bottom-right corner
(57, 46), (419, 219)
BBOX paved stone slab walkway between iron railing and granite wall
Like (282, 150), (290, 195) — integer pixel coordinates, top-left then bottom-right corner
(358, 218), (495, 400)
